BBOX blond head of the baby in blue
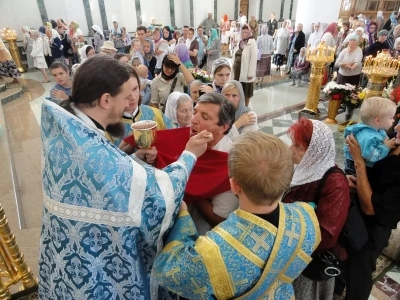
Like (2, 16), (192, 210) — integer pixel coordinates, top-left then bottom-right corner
(360, 97), (396, 130)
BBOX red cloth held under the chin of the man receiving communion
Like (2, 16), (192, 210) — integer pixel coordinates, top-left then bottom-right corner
(124, 127), (230, 203)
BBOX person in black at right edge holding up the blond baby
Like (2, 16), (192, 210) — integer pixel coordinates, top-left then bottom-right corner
(346, 124), (400, 300)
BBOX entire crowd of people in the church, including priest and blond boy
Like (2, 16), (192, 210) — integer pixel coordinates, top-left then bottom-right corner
(0, 8), (400, 300)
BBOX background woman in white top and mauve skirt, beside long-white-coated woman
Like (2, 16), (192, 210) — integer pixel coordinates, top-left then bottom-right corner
(256, 25), (274, 84)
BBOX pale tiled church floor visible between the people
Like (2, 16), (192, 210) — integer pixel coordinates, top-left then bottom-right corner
(0, 71), (400, 300)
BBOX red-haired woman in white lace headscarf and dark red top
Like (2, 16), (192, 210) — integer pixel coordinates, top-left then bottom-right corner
(282, 118), (350, 300)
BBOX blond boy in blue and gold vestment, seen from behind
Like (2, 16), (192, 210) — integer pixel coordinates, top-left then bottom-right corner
(153, 132), (320, 299)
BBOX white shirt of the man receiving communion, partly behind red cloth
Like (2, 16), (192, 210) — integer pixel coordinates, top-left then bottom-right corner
(189, 135), (239, 235)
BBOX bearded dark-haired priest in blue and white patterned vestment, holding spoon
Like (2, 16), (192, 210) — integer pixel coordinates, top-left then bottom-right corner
(39, 56), (212, 300)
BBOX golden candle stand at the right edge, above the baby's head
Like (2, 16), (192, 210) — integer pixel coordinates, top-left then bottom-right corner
(362, 50), (400, 98)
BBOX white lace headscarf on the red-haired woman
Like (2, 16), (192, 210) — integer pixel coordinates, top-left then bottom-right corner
(290, 120), (336, 187)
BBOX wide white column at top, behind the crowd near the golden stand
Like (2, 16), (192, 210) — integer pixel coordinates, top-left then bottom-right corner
(295, 0), (341, 33)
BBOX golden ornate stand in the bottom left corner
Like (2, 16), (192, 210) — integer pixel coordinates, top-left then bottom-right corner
(0, 204), (37, 300)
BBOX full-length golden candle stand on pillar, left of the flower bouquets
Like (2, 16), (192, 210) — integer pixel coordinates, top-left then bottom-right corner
(300, 42), (335, 114)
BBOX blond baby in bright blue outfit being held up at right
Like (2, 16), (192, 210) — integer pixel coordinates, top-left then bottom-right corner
(343, 97), (396, 175)
